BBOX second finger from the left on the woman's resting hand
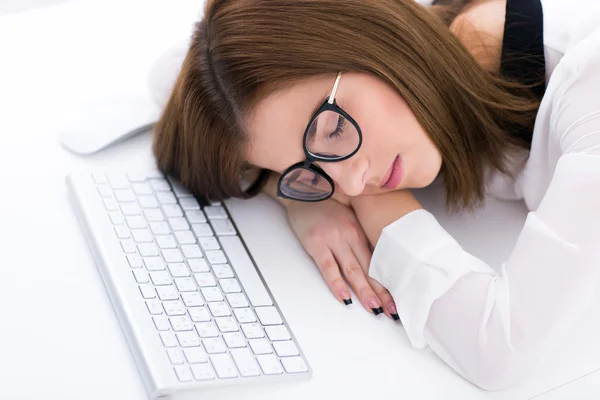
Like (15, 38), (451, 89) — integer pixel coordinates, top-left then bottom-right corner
(333, 243), (383, 315)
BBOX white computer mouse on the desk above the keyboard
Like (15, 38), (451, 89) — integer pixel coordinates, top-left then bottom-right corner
(57, 95), (161, 155)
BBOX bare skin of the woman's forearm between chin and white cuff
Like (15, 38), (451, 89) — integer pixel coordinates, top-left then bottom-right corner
(350, 190), (423, 247)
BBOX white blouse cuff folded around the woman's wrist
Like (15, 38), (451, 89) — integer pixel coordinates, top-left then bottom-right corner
(369, 210), (497, 348)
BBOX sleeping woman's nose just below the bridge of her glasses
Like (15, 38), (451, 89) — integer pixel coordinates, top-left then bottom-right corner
(319, 154), (368, 196)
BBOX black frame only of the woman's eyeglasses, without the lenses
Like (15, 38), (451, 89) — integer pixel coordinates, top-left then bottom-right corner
(277, 72), (362, 203)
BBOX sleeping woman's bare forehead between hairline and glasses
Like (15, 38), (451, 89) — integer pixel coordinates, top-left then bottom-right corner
(246, 75), (335, 172)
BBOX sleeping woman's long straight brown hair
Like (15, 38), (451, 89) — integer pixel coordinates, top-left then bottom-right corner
(153, 0), (539, 210)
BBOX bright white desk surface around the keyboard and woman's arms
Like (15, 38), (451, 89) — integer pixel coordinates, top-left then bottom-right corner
(0, 0), (600, 400)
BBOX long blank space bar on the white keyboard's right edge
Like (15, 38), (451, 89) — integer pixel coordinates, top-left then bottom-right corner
(219, 236), (273, 307)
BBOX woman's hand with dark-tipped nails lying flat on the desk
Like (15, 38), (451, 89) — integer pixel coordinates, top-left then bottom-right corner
(286, 199), (398, 320)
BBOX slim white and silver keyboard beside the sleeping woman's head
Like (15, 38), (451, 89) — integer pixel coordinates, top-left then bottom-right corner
(67, 171), (311, 399)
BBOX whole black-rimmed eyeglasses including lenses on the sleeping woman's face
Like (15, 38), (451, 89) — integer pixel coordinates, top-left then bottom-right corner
(277, 72), (362, 201)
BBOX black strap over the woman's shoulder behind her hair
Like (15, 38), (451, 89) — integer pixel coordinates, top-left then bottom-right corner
(500, 0), (546, 144)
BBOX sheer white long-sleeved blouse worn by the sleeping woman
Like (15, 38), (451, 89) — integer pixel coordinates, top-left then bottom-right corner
(369, 0), (600, 390)
